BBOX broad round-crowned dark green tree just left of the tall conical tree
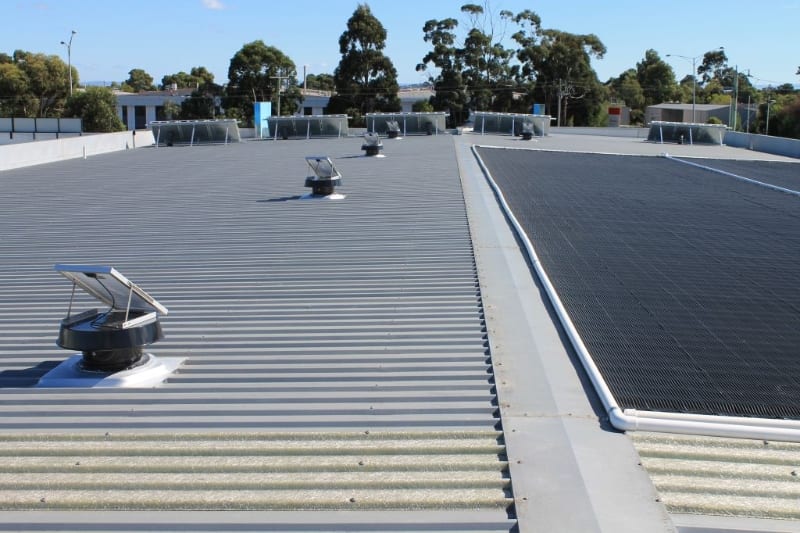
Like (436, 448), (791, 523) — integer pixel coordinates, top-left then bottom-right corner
(224, 40), (302, 124)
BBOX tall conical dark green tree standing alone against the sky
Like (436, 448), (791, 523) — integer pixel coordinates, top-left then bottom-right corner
(328, 4), (401, 124)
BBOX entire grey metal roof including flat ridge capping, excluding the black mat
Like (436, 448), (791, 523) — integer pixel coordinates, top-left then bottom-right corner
(0, 130), (798, 531)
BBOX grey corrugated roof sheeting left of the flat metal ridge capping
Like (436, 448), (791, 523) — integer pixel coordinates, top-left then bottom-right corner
(0, 136), (513, 530)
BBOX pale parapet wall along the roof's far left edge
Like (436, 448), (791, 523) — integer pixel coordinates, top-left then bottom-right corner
(0, 130), (154, 171)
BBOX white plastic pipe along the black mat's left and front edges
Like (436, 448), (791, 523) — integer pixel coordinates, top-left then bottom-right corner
(472, 145), (800, 442)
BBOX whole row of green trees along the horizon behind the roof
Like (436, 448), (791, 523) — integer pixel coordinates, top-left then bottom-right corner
(0, 0), (800, 138)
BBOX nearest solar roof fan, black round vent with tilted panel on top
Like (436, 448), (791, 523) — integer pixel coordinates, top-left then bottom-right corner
(55, 265), (168, 374)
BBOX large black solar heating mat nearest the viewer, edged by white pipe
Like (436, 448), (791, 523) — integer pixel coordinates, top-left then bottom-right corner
(478, 148), (800, 418)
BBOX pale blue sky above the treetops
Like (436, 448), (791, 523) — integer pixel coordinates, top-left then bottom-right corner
(6, 0), (800, 85)
